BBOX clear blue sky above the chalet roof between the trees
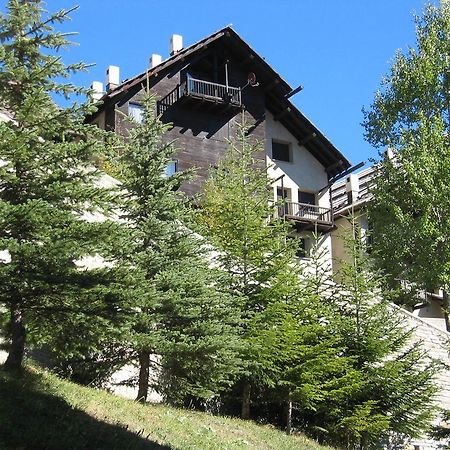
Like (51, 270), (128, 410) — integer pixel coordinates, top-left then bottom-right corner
(1, 0), (437, 163)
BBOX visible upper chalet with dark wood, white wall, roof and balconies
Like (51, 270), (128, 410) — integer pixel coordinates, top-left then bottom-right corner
(88, 27), (350, 253)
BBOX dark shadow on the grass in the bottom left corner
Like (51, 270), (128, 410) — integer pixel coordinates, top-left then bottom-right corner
(0, 366), (170, 450)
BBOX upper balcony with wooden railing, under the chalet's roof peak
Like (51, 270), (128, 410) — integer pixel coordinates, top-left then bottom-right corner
(158, 78), (242, 114)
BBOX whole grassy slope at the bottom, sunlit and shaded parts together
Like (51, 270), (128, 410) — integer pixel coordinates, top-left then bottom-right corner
(0, 368), (326, 450)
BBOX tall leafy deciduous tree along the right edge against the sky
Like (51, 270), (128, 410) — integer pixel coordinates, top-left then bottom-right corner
(364, 2), (450, 310)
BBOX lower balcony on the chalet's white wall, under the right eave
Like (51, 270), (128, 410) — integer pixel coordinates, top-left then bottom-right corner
(278, 200), (334, 232)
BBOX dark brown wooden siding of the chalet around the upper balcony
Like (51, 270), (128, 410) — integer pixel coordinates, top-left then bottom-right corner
(114, 53), (265, 195)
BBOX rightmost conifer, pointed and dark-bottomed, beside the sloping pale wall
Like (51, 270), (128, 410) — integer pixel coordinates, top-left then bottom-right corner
(307, 217), (438, 448)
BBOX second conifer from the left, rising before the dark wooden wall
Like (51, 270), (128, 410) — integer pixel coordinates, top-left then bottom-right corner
(118, 92), (241, 404)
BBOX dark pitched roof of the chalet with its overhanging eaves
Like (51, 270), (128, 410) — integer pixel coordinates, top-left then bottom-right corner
(92, 26), (350, 177)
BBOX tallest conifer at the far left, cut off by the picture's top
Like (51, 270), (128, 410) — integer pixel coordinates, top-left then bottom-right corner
(0, 0), (121, 369)
